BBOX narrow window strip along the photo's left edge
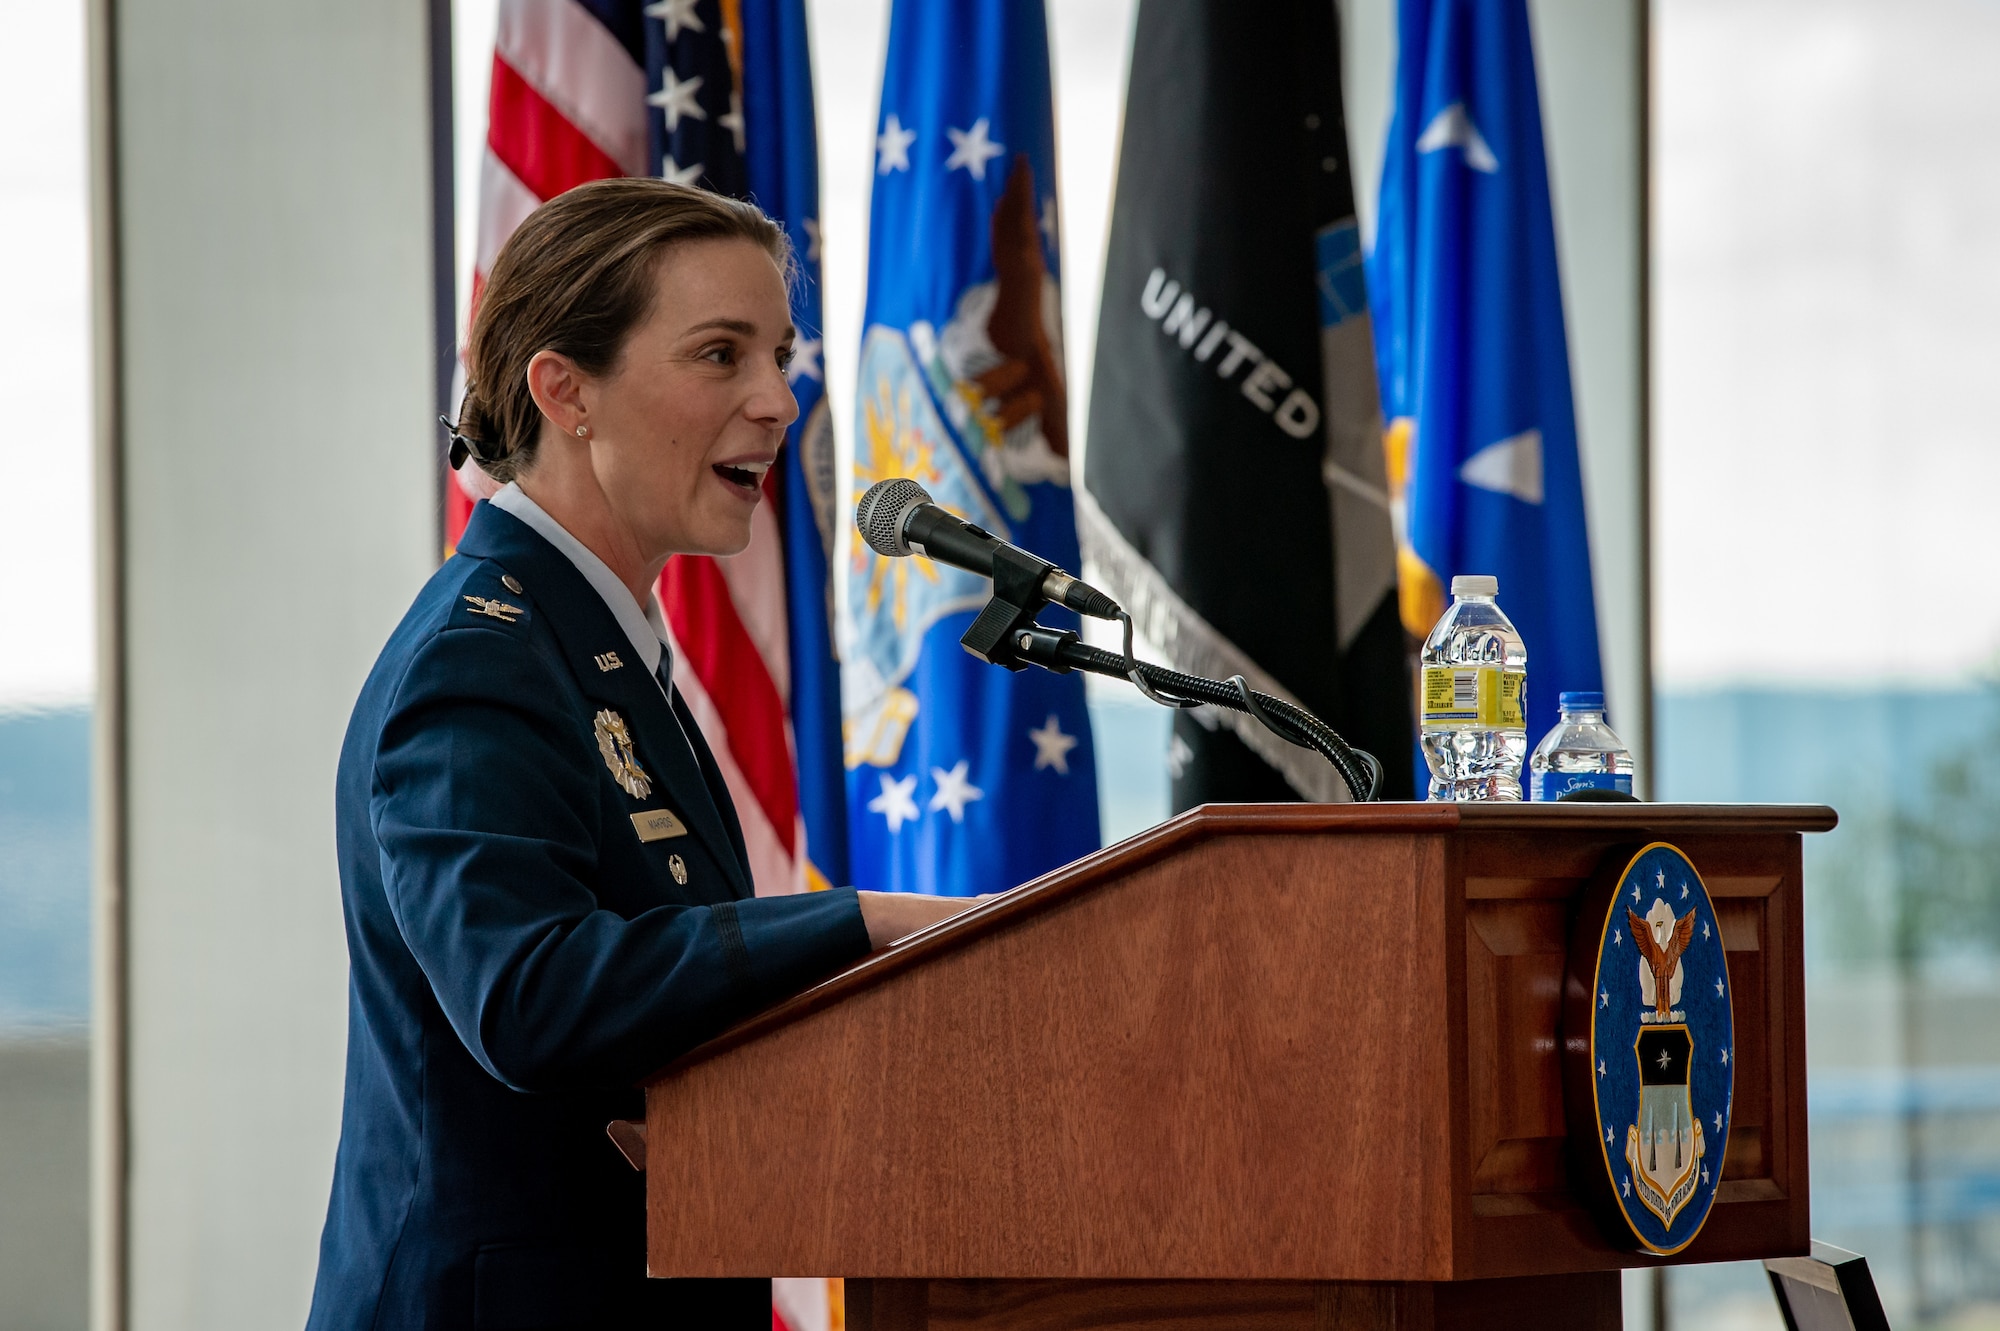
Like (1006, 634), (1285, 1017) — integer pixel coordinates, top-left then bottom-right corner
(0, 0), (94, 1331)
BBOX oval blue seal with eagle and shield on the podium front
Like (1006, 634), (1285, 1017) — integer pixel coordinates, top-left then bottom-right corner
(1564, 841), (1736, 1255)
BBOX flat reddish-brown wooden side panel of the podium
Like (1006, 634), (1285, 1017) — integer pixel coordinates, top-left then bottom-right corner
(648, 833), (1450, 1279)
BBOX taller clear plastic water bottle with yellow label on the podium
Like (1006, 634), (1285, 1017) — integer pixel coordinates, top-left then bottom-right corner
(1422, 576), (1528, 799)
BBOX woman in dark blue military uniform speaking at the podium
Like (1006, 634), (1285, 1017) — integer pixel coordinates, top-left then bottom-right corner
(310, 180), (966, 1331)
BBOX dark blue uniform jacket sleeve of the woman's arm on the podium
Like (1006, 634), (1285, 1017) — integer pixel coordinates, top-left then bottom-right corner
(370, 628), (868, 1091)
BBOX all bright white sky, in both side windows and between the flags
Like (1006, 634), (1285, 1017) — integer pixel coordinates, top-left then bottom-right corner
(0, 0), (2000, 707)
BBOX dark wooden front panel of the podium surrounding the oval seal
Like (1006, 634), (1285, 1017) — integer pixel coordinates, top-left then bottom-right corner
(1456, 823), (1824, 1277)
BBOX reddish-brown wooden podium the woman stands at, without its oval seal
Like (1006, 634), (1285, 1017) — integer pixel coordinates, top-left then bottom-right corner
(646, 803), (1834, 1331)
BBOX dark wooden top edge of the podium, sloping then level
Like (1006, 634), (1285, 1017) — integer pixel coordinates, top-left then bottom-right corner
(646, 801), (1840, 1085)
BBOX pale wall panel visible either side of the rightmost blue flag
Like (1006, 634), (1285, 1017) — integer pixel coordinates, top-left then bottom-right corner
(1340, 0), (1652, 773)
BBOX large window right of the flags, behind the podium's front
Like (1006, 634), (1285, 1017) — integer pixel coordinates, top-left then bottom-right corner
(1654, 0), (2000, 1327)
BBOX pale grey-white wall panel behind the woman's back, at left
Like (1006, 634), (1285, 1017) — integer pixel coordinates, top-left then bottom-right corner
(96, 0), (436, 1331)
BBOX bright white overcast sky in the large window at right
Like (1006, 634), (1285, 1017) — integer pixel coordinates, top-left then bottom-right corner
(1654, 0), (2000, 687)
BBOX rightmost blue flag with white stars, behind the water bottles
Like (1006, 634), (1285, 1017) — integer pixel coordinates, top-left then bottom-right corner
(1368, 0), (1604, 739)
